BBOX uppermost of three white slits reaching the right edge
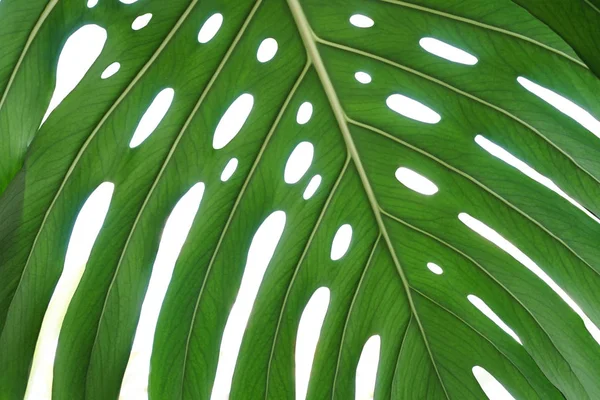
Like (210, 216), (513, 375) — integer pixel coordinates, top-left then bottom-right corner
(517, 76), (600, 138)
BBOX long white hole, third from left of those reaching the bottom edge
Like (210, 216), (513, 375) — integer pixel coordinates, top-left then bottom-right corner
(210, 211), (286, 400)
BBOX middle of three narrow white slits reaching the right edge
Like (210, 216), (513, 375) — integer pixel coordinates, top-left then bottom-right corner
(475, 135), (600, 224)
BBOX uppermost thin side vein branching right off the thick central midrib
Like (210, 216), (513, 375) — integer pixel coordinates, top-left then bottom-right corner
(315, 36), (600, 188)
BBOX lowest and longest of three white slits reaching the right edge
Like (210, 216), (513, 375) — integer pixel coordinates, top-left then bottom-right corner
(458, 213), (600, 344)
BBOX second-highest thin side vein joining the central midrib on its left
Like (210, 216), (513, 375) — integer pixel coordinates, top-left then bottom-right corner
(265, 154), (351, 400)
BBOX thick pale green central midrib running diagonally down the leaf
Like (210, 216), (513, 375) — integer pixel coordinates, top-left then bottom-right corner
(287, 0), (450, 400)
